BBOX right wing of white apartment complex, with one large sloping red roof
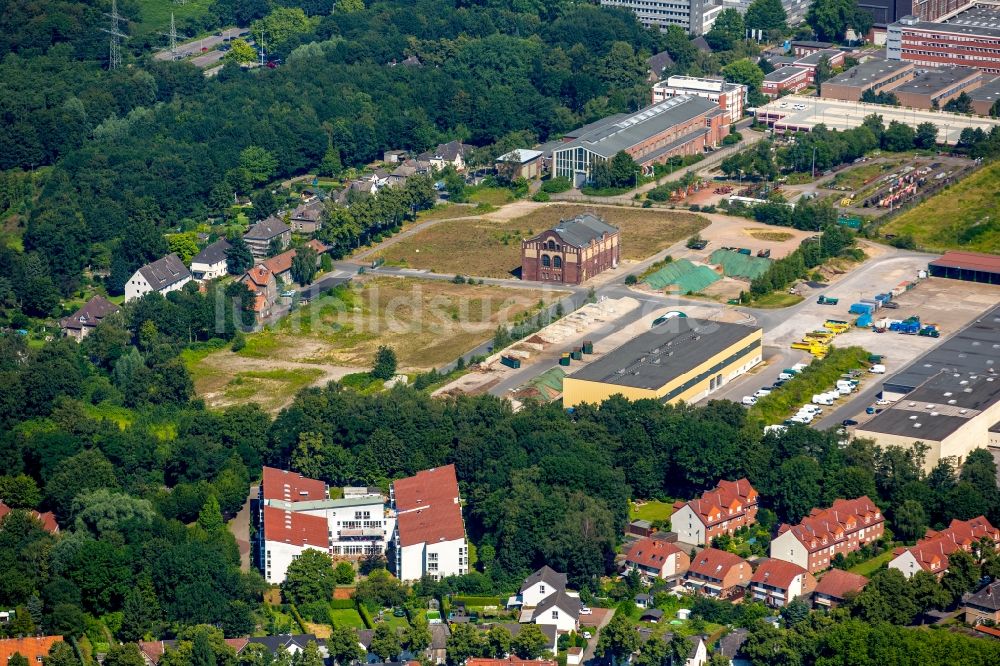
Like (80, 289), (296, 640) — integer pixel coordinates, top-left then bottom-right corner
(389, 465), (469, 581)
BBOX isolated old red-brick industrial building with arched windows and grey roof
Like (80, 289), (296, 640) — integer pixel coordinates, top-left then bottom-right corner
(521, 213), (621, 284)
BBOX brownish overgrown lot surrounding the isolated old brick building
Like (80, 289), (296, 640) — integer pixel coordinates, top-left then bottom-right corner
(382, 205), (709, 278)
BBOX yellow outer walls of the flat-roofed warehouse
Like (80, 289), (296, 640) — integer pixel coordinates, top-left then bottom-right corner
(563, 329), (764, 407)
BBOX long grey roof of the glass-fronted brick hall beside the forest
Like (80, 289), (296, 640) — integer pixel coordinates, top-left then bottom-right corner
(556, 95), (718, 159)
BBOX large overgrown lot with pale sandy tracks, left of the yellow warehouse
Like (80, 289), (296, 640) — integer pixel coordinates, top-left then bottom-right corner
(186, 277), (565, 411)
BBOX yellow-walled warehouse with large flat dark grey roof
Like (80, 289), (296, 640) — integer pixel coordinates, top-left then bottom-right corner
(563, 317), (763, 408)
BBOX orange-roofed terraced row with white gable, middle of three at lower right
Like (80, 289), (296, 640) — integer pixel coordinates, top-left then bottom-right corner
(771, 496), (885, 573)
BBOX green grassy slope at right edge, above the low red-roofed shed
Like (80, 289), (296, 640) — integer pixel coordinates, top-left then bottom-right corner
(881, 162), (1000, 252)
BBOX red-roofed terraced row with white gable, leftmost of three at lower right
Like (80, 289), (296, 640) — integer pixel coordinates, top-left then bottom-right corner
(670, 478), (758, 546)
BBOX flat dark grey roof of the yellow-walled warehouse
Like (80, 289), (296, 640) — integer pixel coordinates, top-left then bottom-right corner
(570, 317), (760, 389)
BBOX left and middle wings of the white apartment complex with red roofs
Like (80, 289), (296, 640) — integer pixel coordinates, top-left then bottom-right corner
(257, 467), (395, 583)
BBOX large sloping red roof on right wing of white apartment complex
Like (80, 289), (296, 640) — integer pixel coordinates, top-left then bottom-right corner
(393, 465), (465, 546)
